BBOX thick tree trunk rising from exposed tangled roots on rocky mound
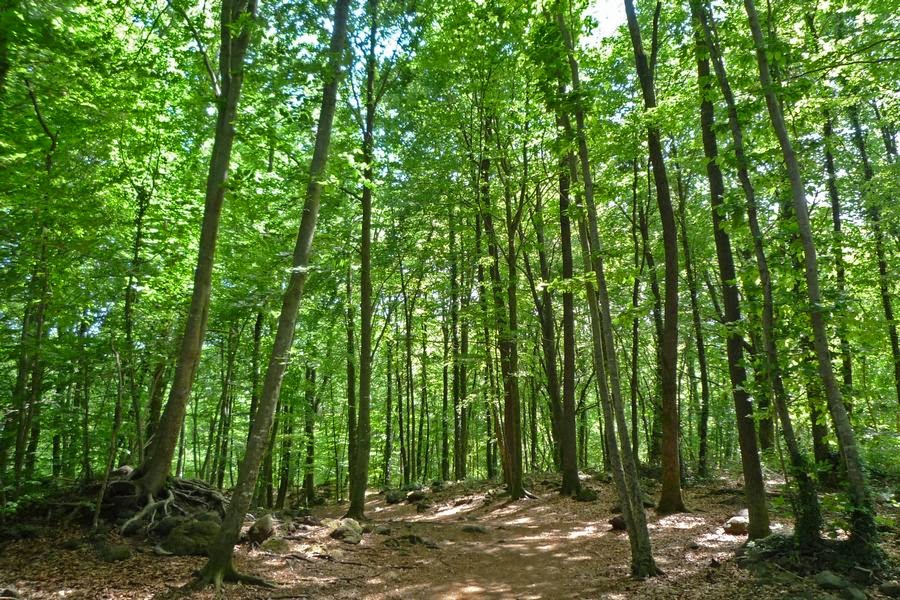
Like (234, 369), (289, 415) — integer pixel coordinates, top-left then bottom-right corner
(135, 0), (256, 496)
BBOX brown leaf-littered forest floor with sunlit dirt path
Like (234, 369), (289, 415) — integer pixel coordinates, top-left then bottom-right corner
(0, 478), (900, 600)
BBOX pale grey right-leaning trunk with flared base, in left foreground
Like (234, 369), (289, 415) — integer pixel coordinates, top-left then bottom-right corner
(200, 0), (350, 587)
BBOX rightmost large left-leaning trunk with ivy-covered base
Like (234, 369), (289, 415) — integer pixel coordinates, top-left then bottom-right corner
(744, 0), (877, 560)
